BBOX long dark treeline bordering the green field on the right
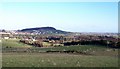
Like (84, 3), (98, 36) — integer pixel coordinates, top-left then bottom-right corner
(64, 40), (120, 48)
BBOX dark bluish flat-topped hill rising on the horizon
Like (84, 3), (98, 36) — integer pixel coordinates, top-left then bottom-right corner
(19, 27), (70, 34)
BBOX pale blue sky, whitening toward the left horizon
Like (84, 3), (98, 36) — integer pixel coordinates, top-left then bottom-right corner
(0, 2), (118, 32)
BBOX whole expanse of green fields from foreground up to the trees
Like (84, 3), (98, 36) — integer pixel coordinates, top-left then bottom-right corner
(2, 39), (118, 67)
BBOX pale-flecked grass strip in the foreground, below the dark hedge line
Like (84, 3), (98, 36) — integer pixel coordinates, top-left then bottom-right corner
(3, 53), (118, 67)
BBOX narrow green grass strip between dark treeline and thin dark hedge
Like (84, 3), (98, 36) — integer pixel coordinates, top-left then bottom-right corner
(31, 45), (106, 51)
